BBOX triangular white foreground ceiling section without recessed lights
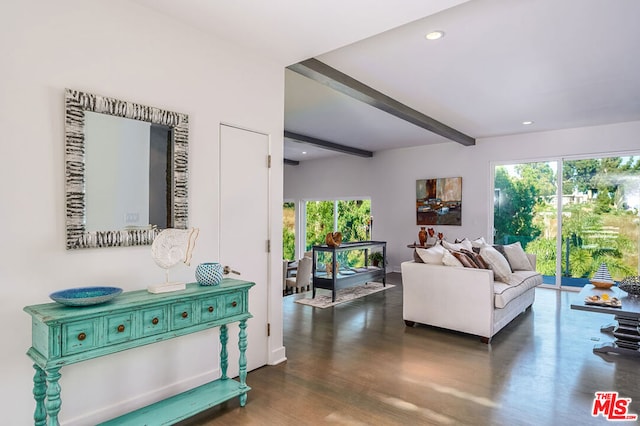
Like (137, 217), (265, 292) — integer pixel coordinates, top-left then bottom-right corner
(134, 0), (468, 66)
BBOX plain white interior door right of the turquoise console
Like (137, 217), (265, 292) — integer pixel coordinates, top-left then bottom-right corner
(220, 125), (269, 374)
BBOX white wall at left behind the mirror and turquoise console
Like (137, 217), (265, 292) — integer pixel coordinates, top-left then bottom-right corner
(0, 0), (284, 425)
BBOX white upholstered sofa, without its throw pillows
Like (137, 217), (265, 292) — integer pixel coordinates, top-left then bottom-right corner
(402, 254), (542, 343)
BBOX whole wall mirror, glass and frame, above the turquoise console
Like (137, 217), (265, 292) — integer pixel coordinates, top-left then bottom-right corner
(65, 89), (189, 249)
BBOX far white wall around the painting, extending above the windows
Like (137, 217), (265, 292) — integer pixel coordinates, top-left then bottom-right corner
(284, 121), (640, 271)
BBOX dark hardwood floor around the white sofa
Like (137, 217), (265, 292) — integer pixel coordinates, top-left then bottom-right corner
(182, 274), (640, 426)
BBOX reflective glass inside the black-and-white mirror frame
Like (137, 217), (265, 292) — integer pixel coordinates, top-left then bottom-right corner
(84, 111), (172, 231)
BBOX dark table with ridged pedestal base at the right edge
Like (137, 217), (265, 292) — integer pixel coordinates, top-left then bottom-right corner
(571, 284), (640, 356)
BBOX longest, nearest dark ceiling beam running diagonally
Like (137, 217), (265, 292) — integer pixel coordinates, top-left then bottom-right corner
(288, 58), (476, 146)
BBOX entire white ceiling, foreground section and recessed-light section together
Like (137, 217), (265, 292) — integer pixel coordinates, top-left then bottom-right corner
(131, 0), (640, 160)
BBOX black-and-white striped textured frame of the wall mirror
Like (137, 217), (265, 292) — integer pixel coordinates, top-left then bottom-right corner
(65, 89), (189, 249)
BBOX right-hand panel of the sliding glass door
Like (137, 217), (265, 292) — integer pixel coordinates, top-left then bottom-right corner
(562, 157), (640, 287)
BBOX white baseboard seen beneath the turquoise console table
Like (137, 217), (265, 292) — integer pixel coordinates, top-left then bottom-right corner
(64, 368), (221, 426)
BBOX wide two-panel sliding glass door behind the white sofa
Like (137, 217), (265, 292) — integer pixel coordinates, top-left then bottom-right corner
(493, 156), (640, 287)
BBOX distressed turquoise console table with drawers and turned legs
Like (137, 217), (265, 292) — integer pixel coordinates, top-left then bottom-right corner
(24, 278), (254, 426)
